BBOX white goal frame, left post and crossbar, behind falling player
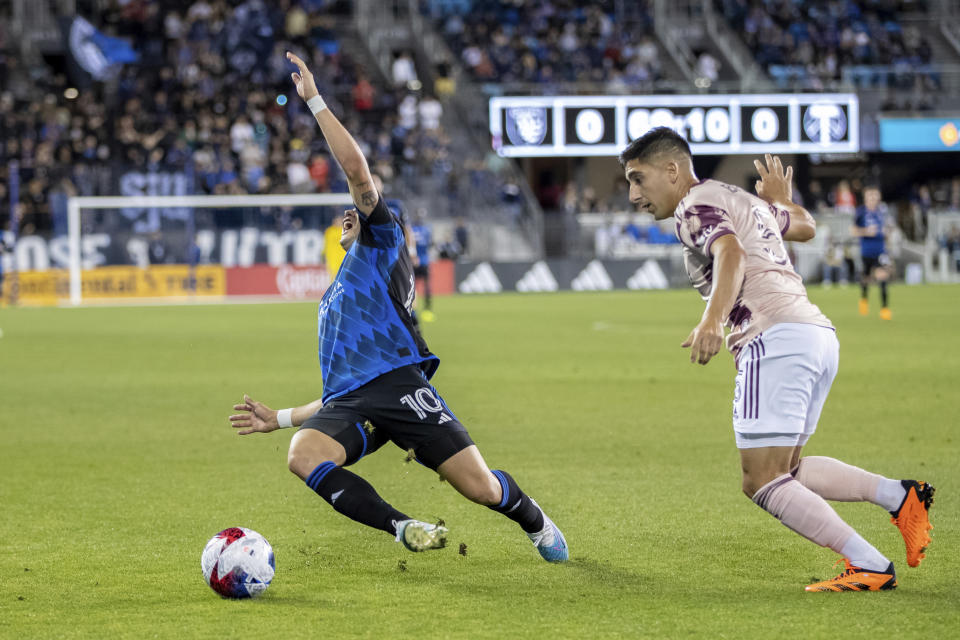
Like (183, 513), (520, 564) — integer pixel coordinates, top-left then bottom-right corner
(67, 193), (353, 305)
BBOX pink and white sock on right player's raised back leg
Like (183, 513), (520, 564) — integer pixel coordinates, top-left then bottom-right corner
(794, 456), (906, 511)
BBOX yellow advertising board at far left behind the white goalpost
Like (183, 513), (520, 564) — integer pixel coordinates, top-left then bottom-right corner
(3, 264), (227, 306)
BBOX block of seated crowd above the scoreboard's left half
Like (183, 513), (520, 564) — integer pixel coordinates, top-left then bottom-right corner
(423, 0), (663, 93)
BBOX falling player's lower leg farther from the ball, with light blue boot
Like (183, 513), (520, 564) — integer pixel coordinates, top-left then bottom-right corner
(437, 445), (569, 562)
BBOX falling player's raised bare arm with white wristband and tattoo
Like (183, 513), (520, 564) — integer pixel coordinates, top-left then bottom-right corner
(287, 51), (379, 215)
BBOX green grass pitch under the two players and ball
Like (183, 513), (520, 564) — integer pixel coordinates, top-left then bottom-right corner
(0, 286), (960, 638)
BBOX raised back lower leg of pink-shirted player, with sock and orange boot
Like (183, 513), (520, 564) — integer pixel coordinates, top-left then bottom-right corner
(793, 456), (935, 567)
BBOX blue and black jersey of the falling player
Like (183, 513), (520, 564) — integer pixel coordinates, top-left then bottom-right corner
(317, 198), (440, 403)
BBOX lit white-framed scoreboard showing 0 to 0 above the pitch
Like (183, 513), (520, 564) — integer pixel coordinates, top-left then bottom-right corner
(490, 93), (860, 157)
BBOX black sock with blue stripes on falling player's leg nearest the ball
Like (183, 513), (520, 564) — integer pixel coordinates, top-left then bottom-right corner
(305, 462), (409, 535)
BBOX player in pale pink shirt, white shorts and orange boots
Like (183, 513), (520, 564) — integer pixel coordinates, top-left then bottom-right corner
(620, 127), (934, 591)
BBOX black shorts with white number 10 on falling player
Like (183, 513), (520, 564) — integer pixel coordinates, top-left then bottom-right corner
(300, 365), (473, 470)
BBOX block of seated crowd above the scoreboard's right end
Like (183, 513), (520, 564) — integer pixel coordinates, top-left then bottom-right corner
(714, 0), (940, 101)
